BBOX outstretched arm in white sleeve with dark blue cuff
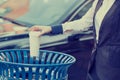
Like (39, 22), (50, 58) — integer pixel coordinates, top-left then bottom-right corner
(52, 0), (98, 33)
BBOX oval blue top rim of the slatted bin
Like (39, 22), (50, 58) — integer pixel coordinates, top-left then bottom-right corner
(0, 49), (76, 67)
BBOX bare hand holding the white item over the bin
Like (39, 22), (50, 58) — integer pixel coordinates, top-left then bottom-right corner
(29, 25), (52, 35)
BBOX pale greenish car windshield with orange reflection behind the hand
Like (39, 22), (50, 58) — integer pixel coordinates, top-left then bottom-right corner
(0, 0), (85, 25)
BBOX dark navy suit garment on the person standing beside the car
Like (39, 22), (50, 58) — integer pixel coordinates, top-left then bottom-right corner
(87, 0), (120, 80)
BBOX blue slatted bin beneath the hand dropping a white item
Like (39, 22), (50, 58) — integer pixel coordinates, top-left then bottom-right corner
(0, 49), (76, 80)
